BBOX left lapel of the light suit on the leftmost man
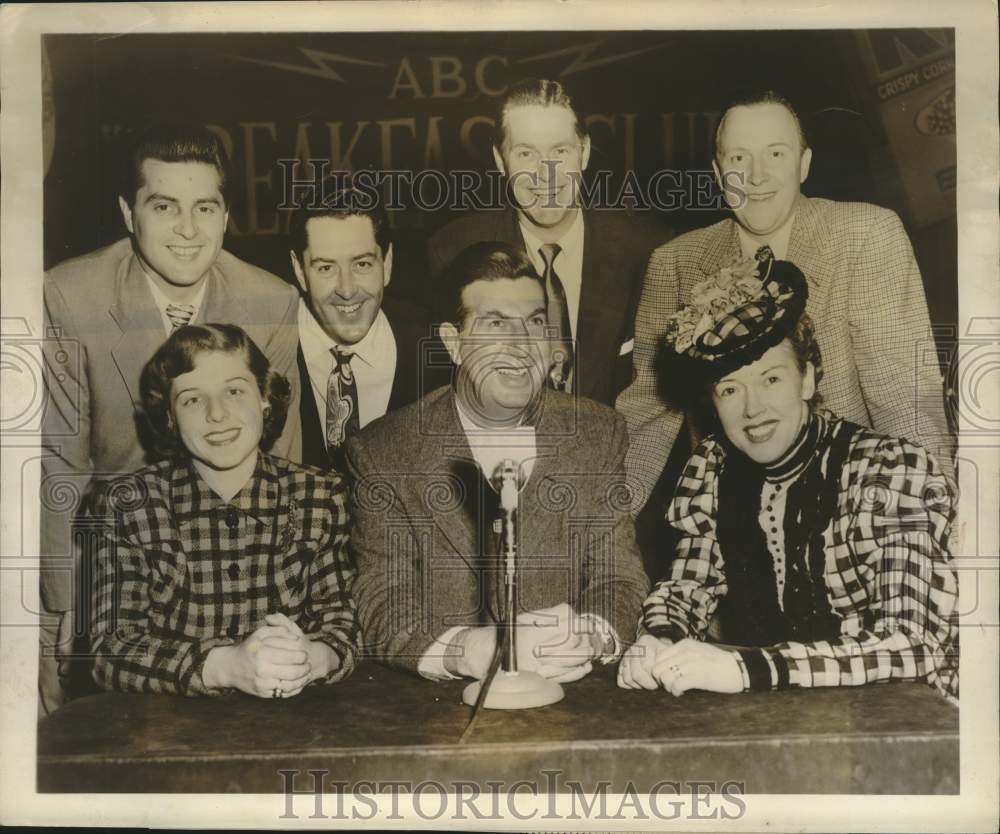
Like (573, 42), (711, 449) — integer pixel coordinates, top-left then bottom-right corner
(108, 255), (166, 407)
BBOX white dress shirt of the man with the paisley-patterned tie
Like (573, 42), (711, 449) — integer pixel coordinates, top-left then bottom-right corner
(298, 299), (396, 432)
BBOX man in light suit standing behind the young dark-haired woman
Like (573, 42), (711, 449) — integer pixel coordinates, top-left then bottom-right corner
(39, 125), (299, 712)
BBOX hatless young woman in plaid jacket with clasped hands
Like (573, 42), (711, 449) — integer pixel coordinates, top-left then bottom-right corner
(93, 324), (358, 698)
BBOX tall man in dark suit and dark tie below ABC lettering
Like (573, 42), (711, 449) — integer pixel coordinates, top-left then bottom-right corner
(428, 79), (667, 405)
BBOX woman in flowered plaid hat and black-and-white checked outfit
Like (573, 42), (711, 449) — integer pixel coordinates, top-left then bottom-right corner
(618, 245), (958, 697)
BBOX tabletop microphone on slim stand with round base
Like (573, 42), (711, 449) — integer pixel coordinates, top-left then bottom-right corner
(462, 459), (564, 704)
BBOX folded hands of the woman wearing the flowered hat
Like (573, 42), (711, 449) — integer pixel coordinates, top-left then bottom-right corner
(618, 634), (743, 695)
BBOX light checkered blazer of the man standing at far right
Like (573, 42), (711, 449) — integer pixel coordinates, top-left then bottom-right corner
(616, 197), (954, 512)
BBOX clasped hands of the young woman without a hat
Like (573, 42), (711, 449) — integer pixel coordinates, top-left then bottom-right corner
(202, 614), (338, 698)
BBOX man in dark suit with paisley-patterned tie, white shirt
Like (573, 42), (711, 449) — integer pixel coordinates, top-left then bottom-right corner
(290, 185), (430, 472)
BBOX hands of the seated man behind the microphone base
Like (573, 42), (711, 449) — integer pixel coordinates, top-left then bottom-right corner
(444, 602), (603, 683)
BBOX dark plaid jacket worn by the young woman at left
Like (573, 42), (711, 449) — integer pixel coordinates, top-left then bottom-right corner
(92, 453), (358, 695)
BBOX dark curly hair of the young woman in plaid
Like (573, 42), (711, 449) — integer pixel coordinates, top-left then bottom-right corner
(139, 324), (291, 458)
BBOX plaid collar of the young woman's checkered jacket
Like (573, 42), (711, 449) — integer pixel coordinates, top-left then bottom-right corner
(170, 452), (281, 527)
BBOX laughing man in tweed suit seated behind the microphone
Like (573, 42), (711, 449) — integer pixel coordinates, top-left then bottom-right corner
(347, 242), (648, 681)
